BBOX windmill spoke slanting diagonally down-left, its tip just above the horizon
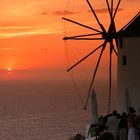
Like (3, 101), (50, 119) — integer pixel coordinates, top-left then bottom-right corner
(67, 44), (103, 72)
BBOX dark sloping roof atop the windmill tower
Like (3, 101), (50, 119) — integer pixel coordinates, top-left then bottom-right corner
(119, 12), (140, 37)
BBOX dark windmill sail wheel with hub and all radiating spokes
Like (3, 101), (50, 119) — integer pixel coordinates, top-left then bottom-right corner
(62, 0), (137, 113)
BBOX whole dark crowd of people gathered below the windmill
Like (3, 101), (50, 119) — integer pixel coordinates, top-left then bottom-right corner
(71, 107), (140, 140)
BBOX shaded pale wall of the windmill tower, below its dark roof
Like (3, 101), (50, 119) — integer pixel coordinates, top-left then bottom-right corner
(118, 37), (140, 112)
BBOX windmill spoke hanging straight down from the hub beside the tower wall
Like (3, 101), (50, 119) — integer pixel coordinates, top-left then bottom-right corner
(108, 44), (114, 114)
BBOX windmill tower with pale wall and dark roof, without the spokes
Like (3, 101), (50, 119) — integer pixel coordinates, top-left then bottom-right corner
(118, 13), (140, 112)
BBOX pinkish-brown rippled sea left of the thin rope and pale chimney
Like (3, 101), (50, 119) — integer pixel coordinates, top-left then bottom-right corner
(0, 80), (117, 140)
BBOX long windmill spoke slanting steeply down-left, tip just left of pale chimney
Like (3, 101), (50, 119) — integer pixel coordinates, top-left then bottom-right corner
(84, 42), (106, 109)
